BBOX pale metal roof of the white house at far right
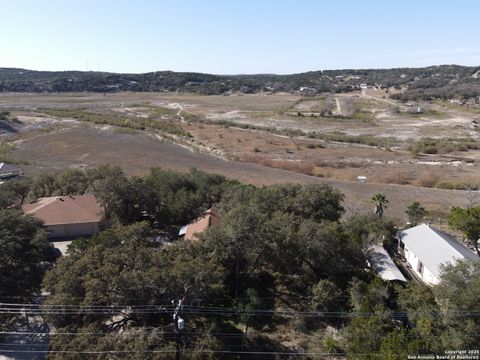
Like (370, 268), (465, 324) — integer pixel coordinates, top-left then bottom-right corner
(399, 224), (480, 278)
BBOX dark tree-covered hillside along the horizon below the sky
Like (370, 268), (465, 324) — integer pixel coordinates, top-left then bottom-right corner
(0, 65), (480, 100)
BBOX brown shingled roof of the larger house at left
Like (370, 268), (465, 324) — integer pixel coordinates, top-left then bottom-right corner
(22, 195), (102, 226)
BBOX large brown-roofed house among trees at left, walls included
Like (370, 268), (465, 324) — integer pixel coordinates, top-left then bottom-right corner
(22, 195), (103, 239)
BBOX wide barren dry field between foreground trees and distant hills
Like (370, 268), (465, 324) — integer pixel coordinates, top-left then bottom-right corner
(0, 93), (480, 222)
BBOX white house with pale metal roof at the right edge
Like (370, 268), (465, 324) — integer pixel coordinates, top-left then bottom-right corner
(398, 224), (480, 285)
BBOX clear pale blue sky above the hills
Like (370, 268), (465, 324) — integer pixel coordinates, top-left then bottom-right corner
(0, 0), (480, 74)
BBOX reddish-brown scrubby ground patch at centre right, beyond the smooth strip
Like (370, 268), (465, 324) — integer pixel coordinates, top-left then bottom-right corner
(187, 124), (479, 187)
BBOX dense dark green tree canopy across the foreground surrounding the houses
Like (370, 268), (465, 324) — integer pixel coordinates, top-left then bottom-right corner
(0, 166), (480, 359)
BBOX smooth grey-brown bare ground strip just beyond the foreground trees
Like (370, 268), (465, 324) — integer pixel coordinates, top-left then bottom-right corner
(12, 126), (474, 222)
